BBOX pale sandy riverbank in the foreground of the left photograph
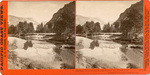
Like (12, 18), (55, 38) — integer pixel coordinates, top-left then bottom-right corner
(8, 37), (72, 69)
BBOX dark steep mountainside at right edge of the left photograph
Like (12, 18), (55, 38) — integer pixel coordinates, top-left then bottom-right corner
(46, 1), (75, 34)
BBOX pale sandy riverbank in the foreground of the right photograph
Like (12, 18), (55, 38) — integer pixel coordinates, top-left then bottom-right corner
(76, 36), (143, 68)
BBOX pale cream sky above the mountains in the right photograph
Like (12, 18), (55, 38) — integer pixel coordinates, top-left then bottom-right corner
(76, 1), (138, 22)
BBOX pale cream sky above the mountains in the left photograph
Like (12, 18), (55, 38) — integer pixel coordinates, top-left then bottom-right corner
(8, 1), (70, 23)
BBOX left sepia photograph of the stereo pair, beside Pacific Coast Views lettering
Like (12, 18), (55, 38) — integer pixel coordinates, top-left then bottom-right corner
(8, 1), (75, 69)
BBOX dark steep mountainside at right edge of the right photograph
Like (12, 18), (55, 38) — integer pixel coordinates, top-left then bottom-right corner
(114, 1), (143, 38)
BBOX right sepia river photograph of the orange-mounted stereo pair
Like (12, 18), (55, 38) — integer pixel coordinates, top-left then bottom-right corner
(76, 0), (143, 69)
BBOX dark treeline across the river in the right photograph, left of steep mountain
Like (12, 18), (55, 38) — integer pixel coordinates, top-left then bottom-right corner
(76, 21), (119, 34)
